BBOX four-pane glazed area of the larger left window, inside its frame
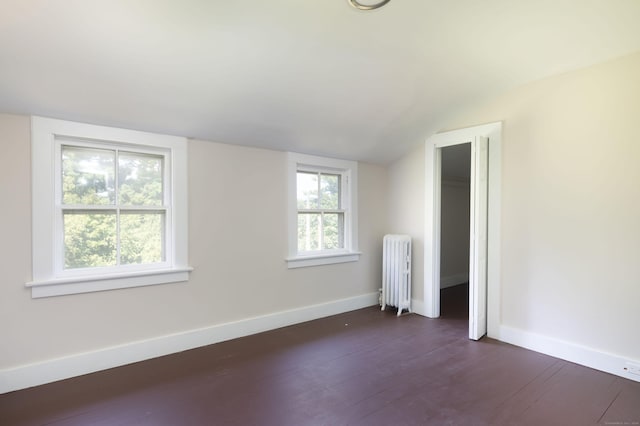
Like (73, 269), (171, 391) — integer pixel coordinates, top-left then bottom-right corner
(56, 145), (166, 271)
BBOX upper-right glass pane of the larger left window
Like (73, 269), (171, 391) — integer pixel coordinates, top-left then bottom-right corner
(118, 152), (163, 206)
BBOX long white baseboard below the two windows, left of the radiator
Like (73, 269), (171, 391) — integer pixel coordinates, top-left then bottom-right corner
(0, 292), (378, 394)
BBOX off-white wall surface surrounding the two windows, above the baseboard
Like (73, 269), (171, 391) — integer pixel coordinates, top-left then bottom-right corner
(0, 115), (388, 389)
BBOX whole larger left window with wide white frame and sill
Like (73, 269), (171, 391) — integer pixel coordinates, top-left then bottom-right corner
(27, 117), (190, 297)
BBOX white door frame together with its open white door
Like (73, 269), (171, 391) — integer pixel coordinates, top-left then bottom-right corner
(424, 122), (502, 340)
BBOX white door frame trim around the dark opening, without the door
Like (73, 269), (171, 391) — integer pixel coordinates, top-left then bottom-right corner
(423, 122), (502, 338)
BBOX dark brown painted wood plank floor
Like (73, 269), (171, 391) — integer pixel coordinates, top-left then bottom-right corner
(0, 288), (640, 426)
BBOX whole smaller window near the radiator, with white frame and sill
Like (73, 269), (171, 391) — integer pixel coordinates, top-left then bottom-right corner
(287, 153), (359, 268)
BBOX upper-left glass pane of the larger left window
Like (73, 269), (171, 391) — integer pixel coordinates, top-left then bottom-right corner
(62, 146), (115, 205)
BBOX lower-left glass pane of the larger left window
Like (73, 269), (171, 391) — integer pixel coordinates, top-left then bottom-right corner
(63, 211), (116, 269)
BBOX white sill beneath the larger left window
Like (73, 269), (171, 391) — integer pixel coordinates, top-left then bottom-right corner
(25, 267), (193, 299)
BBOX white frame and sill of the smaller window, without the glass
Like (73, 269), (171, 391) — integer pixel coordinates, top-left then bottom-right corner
(286, 152), (361, 269)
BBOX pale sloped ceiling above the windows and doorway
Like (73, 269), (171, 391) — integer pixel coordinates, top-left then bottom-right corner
(0, 0), (640, 163)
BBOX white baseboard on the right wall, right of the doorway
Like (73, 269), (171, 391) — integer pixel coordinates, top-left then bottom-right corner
(496, 325), (640, 382)
